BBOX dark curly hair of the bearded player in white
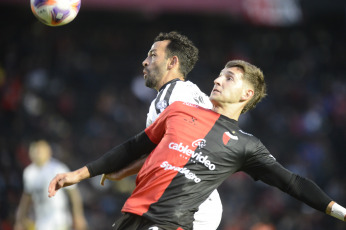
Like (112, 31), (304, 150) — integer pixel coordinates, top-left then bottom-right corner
(154, 31), (198, 78)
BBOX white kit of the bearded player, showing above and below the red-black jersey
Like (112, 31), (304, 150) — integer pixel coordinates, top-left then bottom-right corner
(146, 79), (222, 230)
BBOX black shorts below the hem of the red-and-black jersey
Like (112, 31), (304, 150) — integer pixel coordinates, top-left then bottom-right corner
(113, 213), (183, 230)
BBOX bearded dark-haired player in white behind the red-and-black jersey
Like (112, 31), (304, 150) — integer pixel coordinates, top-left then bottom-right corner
(101, 31), (222, 230)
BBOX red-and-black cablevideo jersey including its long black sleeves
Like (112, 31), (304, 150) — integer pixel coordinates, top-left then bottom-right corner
(86, 102), (332, 230)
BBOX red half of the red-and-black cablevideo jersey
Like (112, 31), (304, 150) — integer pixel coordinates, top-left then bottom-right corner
(122, 102), (220, 215)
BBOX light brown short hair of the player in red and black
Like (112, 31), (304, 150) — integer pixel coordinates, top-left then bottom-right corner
(225, 60), (267, 113)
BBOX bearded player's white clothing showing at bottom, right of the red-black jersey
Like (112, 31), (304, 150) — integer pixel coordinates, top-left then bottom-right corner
(193, 189), (222, 230)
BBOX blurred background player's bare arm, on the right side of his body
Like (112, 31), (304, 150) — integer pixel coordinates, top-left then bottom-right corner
(67, 188), (87, 230)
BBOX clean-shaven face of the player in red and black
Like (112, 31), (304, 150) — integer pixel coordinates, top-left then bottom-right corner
(210, 67), (249, 105)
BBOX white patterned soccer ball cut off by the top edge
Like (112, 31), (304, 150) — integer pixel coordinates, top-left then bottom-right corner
(30, 0), (81, 26)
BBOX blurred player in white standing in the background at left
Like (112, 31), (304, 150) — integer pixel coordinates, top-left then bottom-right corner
(14, 140), (87, 230)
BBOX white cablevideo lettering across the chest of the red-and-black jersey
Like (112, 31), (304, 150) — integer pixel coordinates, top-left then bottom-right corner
(168, 142), (215, 170)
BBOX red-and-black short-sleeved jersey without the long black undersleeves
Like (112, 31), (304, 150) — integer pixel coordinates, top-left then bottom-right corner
(122, 102), (275, 229)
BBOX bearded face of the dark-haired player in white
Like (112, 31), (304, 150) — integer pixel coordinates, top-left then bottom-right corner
(142, 40), (169, 90)
